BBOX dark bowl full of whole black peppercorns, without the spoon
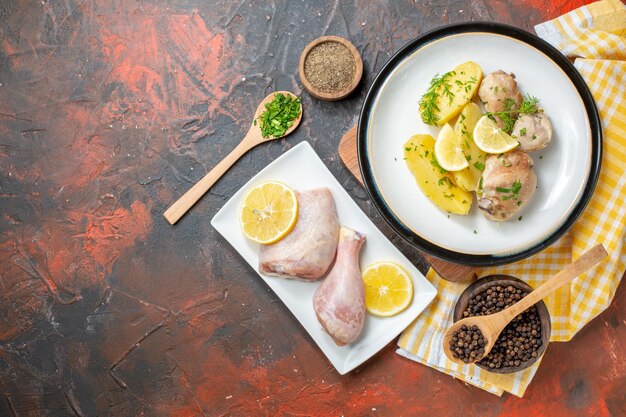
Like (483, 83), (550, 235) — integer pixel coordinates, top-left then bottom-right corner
(444, 275), (551, 374)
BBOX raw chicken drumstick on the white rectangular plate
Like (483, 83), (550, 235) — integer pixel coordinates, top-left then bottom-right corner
(313, 227), (365, 346)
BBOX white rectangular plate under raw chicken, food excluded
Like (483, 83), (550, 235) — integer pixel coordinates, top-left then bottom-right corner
(211, 142), (437, 375)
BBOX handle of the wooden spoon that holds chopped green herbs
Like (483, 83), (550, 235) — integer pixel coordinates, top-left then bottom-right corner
(163, 136), (256, 224)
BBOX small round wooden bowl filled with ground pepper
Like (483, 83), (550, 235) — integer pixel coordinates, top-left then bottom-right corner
(298, 36), (363, 101)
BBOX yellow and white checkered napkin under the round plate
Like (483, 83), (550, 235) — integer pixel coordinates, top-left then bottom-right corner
(398, 0), (626, 397)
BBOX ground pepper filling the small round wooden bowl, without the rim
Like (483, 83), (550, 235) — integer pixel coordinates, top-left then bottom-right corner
(304, 41), (356, 93)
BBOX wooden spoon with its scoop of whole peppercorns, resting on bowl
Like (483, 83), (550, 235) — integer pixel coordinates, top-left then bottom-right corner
(443, 244), (608, 365)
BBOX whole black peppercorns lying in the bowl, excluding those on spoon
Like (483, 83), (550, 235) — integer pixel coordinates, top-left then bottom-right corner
(463, 285), (542, 369)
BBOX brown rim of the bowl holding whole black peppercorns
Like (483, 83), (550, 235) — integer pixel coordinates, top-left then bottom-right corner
(453, 275), (552, 374)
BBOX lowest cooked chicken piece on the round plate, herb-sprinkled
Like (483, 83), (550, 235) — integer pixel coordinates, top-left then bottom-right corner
(478, 150), (537, 221)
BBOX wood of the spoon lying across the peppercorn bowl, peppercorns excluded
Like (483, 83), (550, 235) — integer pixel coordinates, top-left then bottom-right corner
(443, 244), (607, 365)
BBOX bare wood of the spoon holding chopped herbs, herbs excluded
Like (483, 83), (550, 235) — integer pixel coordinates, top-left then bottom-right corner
(163, 91), (302, 224)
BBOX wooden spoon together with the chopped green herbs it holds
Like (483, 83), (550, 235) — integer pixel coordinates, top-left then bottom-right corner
(163, 91), (302, 224)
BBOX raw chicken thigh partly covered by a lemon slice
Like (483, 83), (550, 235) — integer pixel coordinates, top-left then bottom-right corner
(259, 188), (339, 281)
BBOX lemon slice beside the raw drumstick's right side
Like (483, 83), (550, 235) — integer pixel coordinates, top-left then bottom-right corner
(363, 261), (413, 317)
